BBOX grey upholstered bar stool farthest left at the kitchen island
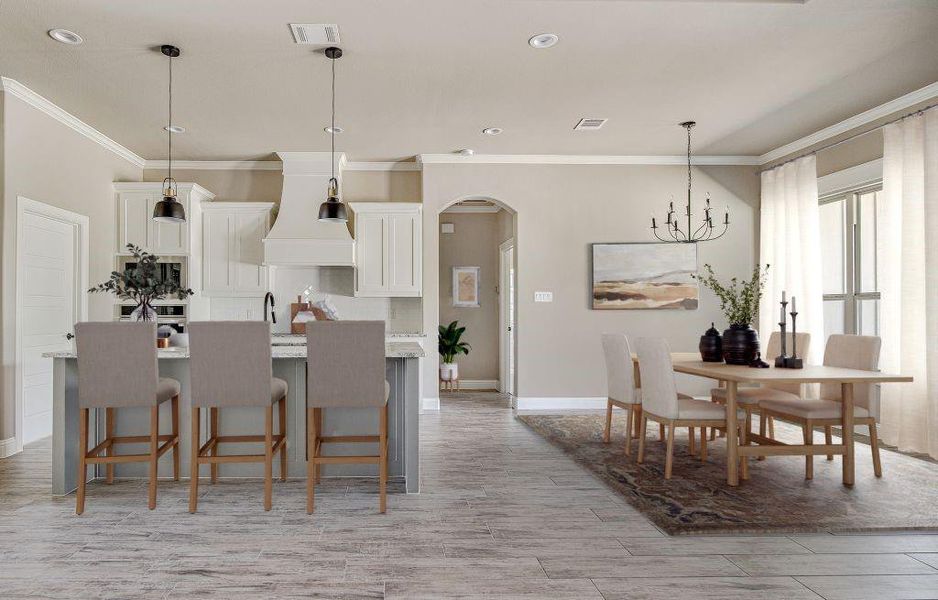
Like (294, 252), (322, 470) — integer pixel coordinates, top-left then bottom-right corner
(75, 323), (179, 515)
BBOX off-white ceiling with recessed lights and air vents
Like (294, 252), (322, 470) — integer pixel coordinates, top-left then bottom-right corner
(0, 0), (938, 161)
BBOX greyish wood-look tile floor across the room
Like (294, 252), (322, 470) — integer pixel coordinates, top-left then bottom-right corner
(0, 392), (938, 600)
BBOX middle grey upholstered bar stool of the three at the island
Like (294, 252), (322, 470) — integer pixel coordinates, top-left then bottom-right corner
(189, 321), (287, 513)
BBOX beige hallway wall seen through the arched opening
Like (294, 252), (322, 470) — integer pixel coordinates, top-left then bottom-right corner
(439, 211), (507, 380)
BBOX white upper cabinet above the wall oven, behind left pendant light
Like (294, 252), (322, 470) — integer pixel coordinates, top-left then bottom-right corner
(114, 182), (214, 256)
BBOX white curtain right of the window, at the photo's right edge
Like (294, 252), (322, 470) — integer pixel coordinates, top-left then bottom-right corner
(876, 109), (938, 457)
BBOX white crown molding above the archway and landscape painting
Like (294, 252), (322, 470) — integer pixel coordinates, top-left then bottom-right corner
(417, 154), (761, 166)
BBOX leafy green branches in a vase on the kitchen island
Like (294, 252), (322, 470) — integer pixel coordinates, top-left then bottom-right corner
(88, 244), (194, 321)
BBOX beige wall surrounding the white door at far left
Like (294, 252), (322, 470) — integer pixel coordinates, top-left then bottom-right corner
(0, 94), (143, 439)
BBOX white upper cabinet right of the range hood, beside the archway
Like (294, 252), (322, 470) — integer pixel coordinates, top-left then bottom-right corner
(349, 202), (423, 297)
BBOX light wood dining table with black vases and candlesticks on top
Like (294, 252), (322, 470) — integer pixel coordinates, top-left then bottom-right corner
(633, 352), (912, 486)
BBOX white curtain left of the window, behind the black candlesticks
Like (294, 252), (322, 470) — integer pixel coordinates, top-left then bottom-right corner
(759, 155), (826, 364)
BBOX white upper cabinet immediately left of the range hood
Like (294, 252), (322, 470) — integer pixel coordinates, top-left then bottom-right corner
(202, 202), (274, 297)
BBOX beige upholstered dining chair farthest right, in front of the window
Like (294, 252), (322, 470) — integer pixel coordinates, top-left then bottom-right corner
(759, 335), (883, 479)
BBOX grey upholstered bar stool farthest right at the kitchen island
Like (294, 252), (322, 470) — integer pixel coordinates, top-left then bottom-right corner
(306, 321), (390, 514)
